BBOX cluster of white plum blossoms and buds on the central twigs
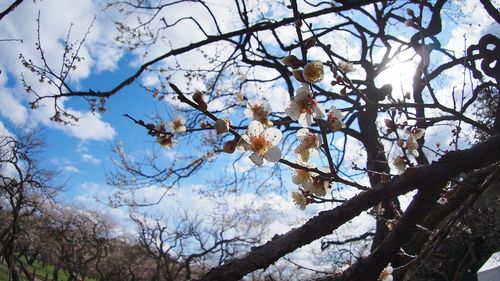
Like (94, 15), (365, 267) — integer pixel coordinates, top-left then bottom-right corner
(157, 55), (353, 209)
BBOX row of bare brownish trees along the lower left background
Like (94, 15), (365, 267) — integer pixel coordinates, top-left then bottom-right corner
(0, 134), (217, 281)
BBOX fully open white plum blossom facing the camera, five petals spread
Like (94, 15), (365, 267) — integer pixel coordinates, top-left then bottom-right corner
(239, 120), (282, 166)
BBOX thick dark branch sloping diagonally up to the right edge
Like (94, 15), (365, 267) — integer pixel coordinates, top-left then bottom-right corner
(200, 135), (500, 280)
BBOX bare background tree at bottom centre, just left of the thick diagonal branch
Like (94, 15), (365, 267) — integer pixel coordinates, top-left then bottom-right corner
(132, 207), (265, 281)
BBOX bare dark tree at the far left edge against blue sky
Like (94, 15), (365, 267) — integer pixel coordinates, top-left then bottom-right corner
(0, 133), (61, 281)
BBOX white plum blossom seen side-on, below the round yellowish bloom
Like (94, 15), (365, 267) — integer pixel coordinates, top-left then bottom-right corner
(285, 84), (325, 127)
